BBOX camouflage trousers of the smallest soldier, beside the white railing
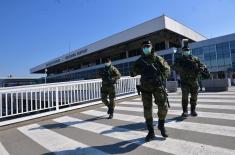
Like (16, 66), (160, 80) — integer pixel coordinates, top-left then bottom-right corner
(101, 84), (115, 109)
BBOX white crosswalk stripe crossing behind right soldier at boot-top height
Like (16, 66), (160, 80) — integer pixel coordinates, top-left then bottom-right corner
(118, 101), (235, 110)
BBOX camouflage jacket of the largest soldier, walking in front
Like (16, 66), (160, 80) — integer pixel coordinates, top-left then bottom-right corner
(132, 55), (170, 87)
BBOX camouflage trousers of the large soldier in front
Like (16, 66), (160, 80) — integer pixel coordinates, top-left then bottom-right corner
(141, 87), (168, 122)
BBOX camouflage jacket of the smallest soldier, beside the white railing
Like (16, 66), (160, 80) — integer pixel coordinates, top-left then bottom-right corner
(99, 65), (121, 85)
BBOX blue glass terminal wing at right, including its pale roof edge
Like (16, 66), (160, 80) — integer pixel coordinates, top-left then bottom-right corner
(189, 33), (235, 79)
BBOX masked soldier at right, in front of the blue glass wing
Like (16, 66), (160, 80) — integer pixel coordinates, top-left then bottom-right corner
(173, 39), (210, 117)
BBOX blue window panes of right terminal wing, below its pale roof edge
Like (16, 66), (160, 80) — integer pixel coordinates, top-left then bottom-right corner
(192, 41), (235, 72)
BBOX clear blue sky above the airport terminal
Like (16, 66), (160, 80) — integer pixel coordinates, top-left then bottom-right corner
(0, 0), (235, 77)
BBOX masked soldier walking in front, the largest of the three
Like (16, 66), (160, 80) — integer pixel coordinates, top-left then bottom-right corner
(131, 41), (170, 142)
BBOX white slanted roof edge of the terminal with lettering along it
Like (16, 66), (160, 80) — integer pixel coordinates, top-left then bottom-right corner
(30, 16), (207, 73)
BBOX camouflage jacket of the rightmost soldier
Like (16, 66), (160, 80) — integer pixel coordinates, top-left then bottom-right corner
(172, 54), (206, 82)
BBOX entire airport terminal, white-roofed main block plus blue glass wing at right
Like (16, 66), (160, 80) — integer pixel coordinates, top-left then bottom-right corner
(31, 16), (235, 82)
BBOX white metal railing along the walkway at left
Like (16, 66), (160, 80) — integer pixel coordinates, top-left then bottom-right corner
(0, 77), (139, 124)
